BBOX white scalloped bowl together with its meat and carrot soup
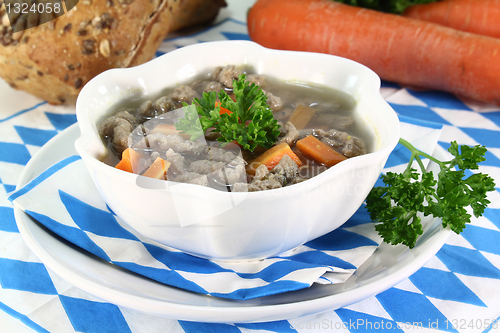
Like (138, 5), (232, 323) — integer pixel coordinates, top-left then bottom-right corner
(75, 41), (399, 260)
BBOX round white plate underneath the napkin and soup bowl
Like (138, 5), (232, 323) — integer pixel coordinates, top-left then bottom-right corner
(14, 125), (450, 323)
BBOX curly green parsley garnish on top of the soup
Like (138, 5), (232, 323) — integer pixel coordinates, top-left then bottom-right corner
(175, 74), (280, 151)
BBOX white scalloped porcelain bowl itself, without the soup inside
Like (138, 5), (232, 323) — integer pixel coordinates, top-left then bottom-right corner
(75, 41), (399, 260)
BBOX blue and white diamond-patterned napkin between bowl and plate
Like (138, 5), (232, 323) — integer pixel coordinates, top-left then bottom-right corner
(9, 117), (441, 300)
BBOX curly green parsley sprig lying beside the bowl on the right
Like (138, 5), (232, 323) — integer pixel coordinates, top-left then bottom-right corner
(366, 139), (495, 248)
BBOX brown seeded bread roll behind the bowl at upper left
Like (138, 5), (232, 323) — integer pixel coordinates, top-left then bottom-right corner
(0, 0), (226, 104)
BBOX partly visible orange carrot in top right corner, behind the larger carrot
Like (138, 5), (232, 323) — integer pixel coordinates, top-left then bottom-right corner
(403, 0), (500, 38)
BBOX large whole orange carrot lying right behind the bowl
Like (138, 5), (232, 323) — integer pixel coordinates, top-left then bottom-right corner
(248, 0), (500, 105)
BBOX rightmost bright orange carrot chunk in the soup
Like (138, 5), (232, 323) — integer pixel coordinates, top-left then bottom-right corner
(296, 135), (347, 167)
